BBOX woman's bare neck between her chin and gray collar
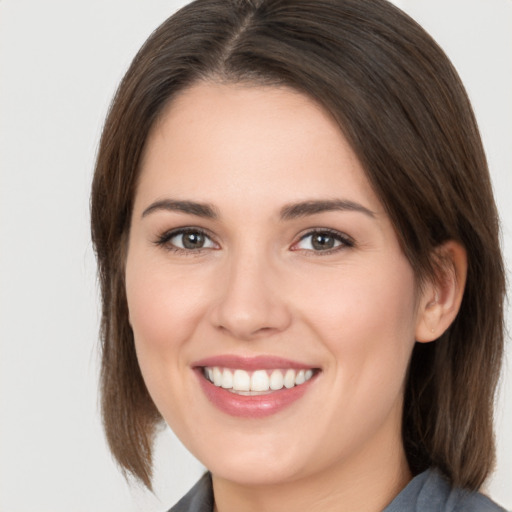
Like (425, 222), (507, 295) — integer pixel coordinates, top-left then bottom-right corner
(212, 428), (411, 512)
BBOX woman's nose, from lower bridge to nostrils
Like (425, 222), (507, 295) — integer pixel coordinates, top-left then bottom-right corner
(211, 254), (291, 340)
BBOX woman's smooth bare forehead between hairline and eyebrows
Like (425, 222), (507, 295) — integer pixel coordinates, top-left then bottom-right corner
(134, 82), (380, 215)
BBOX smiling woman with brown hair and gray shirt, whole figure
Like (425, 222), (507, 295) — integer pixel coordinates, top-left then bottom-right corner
(92, 0), (504, 512)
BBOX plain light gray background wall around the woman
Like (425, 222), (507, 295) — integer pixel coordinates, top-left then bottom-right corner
(0, 0), (512, 512)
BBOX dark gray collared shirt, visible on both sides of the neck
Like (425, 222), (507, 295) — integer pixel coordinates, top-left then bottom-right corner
(169, 469), (506, 512)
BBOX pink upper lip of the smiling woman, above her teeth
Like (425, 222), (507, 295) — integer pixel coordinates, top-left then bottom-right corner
(192, 354), (316, 371)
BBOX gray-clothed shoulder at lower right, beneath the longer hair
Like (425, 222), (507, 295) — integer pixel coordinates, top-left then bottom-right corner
(384, 469), (506, 512)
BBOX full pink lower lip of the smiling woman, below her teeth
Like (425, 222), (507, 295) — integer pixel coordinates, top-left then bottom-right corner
(196, 368), (315, 418)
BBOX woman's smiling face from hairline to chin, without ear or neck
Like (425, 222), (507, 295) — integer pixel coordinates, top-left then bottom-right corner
(126, 83), (428, 484)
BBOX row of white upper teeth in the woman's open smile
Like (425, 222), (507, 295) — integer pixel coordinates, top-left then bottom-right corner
(203, 366), (314, 394)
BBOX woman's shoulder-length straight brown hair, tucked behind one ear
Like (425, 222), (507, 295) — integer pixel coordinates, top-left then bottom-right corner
(91, 0), (505, 489)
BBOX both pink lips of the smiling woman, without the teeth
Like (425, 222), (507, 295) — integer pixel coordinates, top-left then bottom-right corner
(193, 355), (317, 418)
